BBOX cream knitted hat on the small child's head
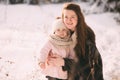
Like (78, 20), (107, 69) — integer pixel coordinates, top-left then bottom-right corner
(52, 19), (70, 33)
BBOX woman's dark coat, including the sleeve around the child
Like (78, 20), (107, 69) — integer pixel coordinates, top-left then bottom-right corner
(63, 28), (104, 80)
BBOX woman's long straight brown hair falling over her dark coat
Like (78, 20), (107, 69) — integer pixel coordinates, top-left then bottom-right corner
(62, 3), (87, 57)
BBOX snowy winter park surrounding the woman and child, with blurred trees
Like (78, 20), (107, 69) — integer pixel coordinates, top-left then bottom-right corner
(0, 0), (120, 80)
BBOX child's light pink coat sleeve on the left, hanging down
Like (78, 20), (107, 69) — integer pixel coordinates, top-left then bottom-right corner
(39, 41), (52, 62)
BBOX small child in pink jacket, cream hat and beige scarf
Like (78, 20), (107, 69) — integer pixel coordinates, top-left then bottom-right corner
(39, 19), (73, 80)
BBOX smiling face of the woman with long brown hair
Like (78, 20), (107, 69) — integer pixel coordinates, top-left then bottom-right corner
(63, 10), (78, 31)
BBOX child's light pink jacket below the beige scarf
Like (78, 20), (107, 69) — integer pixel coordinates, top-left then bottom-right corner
(40, 41), (74, 79)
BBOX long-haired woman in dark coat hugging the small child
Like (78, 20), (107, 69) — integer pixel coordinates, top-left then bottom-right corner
(45, 3), (104, 80)
